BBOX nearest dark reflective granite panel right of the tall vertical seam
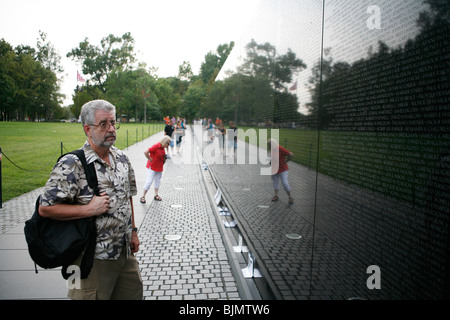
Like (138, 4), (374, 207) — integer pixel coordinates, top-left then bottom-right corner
(316, 1), (450, 298)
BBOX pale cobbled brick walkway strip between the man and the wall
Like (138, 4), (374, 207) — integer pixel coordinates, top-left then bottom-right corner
(136, 130), (240, 300)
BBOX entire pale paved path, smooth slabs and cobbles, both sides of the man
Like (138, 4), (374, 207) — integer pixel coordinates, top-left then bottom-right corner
(0, 127), (246, 300)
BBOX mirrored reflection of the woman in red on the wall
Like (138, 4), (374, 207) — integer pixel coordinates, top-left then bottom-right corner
(267, 139), (294, 204)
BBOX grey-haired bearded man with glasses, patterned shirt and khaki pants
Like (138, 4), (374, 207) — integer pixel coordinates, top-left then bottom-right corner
(39, 100), (143, 300)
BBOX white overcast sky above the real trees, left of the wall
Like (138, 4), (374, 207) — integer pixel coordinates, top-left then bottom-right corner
(0, 0), (260, 105)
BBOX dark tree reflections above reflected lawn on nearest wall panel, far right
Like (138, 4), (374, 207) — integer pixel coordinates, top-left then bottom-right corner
(309, 0), (450, 133)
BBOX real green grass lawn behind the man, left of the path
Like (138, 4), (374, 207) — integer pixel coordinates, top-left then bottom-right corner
(0, 122), (164, 201)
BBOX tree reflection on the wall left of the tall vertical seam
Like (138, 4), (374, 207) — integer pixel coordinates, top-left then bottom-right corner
(203, 40), (306, 123)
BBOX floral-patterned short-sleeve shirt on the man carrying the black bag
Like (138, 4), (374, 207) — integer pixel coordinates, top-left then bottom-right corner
(40, 141), (137, 260)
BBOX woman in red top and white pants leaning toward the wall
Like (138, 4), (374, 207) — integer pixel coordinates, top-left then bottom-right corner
(140, 136), (172, 203)
